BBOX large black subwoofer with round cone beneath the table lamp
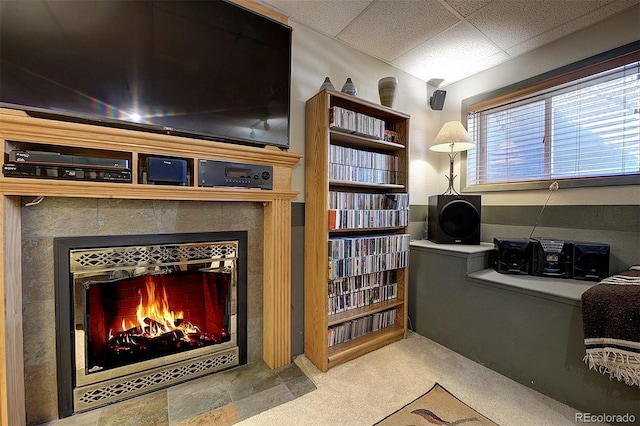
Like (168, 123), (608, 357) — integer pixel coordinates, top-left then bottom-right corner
(427, 195), (481, 244)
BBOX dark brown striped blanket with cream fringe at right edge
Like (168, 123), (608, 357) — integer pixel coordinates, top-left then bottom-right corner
(582, 266), (640, 386)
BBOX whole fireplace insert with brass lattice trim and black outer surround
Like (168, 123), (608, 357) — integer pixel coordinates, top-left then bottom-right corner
(54, 231), (247, 417)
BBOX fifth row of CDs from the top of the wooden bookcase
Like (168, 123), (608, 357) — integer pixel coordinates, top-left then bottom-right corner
(328, 270), (398, 315)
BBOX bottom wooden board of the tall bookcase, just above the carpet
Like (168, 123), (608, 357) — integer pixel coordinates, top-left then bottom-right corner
(328, 324), (405, 368)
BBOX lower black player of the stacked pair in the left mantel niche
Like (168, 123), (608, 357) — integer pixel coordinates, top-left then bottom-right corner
(2, 163), (131, 183)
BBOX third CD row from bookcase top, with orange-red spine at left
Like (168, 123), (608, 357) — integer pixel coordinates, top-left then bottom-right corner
(328, 191), (409, 230)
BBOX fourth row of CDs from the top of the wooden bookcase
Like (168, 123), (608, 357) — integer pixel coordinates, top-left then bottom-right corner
(329, 234), (410, 280)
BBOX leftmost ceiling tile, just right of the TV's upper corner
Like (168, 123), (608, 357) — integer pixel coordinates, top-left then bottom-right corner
(265, 0), (373, 37)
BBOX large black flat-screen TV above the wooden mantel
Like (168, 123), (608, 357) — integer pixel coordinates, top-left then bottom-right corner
(0, 0), (291, 148)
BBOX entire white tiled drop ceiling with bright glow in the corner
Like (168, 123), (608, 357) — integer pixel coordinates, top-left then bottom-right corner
(263, 0), (640, 87)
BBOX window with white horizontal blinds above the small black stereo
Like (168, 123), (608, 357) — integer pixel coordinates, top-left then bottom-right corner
(467, 53), (640, 186)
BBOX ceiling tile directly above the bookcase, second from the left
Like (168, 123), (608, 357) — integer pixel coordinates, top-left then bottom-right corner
(338, 0), (459, 61)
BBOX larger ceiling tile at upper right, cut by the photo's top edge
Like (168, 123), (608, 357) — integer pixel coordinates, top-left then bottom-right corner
(468, 0), (614, 50)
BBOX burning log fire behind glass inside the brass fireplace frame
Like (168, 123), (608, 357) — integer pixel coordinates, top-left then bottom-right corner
(83, 271), (231, 373)
